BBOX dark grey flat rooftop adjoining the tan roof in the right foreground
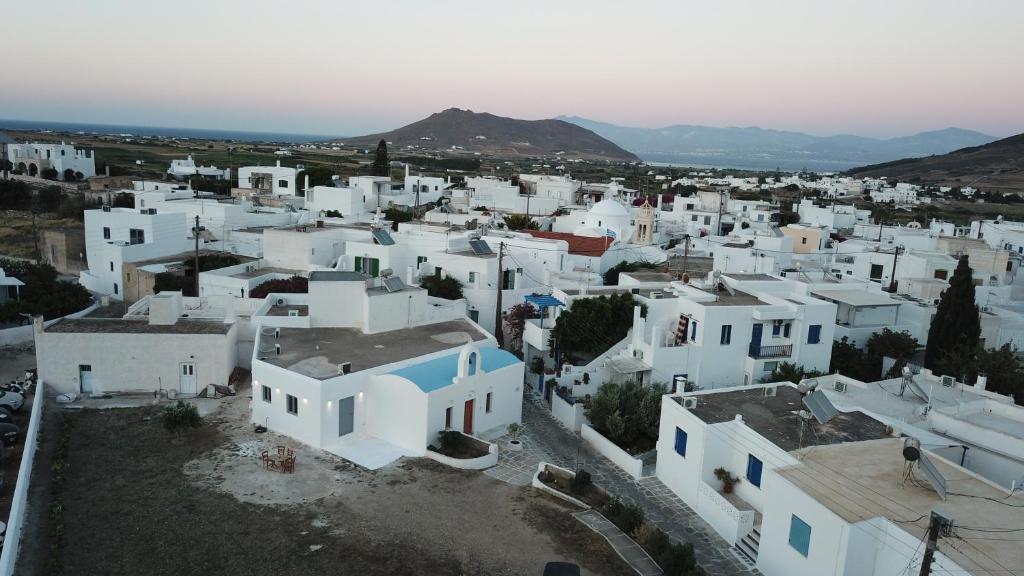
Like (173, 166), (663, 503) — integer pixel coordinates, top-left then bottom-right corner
(675, 385), (889, 452)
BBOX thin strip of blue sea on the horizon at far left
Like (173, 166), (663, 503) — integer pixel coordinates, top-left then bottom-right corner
(0, 118), (339, 143)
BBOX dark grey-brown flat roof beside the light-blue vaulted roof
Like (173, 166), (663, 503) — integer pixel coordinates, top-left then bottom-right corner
(259, 320), (485, 380)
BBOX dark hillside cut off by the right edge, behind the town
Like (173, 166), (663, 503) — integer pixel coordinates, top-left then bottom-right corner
(848, 134), (1024, 194)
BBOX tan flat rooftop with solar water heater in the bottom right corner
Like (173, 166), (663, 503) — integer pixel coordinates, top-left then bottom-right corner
(775, 438), (1024, 576)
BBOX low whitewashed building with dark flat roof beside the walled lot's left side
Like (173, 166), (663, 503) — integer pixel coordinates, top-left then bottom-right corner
(35, 292), (246, 397)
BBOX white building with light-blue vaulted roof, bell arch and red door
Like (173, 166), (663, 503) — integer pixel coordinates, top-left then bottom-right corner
(245, 272), (523, 468)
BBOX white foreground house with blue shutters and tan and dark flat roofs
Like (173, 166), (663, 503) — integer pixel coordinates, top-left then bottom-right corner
(657, 383), (1024, 576)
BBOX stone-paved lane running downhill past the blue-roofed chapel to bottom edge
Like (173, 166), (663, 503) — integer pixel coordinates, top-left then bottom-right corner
(484, 389), (758, 576)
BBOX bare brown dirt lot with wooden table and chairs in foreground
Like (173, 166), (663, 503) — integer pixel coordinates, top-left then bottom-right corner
(17, 387), (631, 575)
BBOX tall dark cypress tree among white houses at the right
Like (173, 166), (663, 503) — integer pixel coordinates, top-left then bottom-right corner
(925, 255), (981, 370)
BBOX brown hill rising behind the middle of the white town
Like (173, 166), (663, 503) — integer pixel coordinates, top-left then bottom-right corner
(342, 108), (638, 161)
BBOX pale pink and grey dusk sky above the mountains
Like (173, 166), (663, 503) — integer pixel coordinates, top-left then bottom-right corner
(0, 0), (1024, 137)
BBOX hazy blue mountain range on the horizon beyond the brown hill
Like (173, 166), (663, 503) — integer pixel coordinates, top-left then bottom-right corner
(558, 116), (995, 171)
